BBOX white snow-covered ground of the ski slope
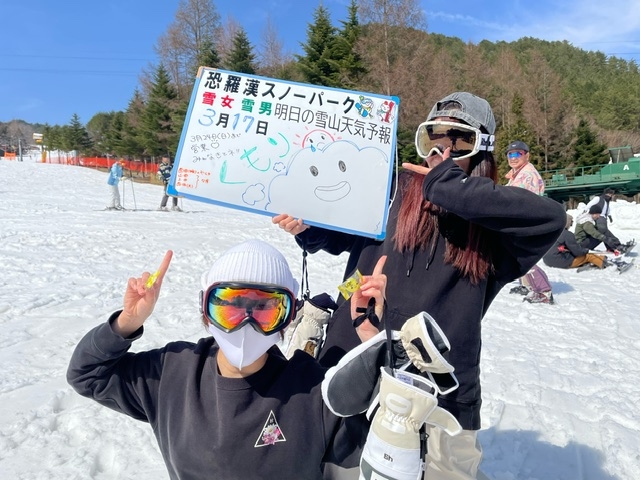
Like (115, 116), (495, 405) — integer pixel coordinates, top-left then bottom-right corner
(0, 159), (640, 480)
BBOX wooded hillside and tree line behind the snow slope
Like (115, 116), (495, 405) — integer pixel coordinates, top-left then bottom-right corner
(16, 0), (640, 180)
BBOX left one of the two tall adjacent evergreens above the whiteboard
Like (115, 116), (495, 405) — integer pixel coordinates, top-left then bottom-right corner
(296, 4), (340, 87)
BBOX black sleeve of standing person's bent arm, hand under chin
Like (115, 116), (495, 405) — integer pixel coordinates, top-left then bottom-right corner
(423, 159), (566, 275)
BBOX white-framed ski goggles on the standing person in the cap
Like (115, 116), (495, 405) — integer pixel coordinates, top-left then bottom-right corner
(416, 120), (495, 160)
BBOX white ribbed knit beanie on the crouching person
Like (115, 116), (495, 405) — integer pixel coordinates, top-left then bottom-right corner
(202, 240), (298, 295)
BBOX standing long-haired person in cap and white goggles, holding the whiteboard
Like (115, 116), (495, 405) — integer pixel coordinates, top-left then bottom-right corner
(272, 92), (565, 479)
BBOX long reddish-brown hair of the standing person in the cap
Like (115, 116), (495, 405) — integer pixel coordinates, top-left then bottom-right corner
(393, 151), (498, 285)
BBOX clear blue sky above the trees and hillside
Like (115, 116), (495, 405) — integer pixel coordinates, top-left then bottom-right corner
(0, 0), (640, 125)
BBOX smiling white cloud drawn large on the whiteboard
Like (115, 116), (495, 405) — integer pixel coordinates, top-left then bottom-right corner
(267, 141), (389, 235)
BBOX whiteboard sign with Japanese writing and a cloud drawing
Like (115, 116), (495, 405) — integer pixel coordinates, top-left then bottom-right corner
(169, 68), (399, 239)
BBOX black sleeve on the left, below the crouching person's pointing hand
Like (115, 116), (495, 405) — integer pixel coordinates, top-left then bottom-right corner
(67, 311), (161, 422)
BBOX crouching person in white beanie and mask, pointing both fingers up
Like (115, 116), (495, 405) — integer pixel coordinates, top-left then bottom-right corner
(67, 240), (386, 479)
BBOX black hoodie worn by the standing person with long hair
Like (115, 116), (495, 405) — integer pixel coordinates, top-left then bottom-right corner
(296, 160), (566, 430)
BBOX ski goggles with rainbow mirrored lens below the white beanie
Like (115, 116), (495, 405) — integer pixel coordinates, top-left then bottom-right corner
(200, 282), (296, 335)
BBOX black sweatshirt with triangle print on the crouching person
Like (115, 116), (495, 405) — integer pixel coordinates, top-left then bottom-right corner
(67, 312), (362, 480)
